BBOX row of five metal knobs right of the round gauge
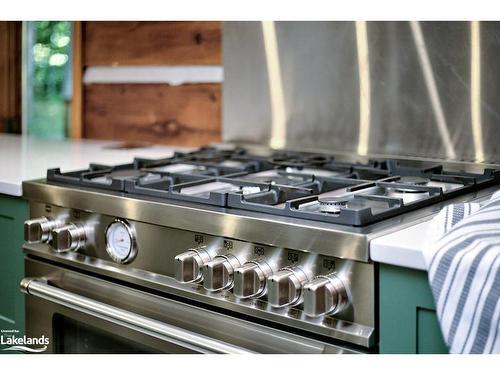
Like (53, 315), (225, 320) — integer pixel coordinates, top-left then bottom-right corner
(175, 248), (349, 317)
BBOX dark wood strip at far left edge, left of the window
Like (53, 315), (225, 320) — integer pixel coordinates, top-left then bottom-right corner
(0, 21), (22, 133)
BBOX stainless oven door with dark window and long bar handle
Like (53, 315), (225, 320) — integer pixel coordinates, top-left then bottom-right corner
(21, 257), (355, 353)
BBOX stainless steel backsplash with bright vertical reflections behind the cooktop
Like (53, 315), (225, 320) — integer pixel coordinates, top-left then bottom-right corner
(223, 22), (500, 162)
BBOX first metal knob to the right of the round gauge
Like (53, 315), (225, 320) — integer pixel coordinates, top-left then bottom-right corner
(175, 249), (212, 283)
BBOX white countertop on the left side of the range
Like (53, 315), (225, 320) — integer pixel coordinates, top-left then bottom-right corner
(0, 134), (191, 196)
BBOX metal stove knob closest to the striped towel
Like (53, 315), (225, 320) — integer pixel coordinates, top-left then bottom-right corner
(304, 273), (349, 317)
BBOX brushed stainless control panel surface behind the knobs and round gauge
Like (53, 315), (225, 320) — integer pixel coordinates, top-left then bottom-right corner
(24, 198), (375, 346)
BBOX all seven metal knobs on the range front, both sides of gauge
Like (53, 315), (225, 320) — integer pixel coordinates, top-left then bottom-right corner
(24, 217), (349, 317)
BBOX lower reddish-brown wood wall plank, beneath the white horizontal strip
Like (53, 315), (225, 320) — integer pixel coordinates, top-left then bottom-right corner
(84, 84), (221, 146)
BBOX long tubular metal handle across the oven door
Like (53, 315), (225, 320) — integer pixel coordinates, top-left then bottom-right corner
(21, 278), (253, 354)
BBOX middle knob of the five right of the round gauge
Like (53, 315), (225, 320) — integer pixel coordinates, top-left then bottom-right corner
(233, 260), (273, 298)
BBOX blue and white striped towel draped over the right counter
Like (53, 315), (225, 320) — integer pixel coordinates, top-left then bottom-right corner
(424, 191), (500, 353)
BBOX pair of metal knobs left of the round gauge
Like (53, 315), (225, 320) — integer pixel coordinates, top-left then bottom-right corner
(24, 216), (86, 252)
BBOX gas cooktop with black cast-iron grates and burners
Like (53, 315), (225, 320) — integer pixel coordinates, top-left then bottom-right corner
(47, 147), (500, 226)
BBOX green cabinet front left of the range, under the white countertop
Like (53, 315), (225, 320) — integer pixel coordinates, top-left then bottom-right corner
(0, 194), (28, 342)
